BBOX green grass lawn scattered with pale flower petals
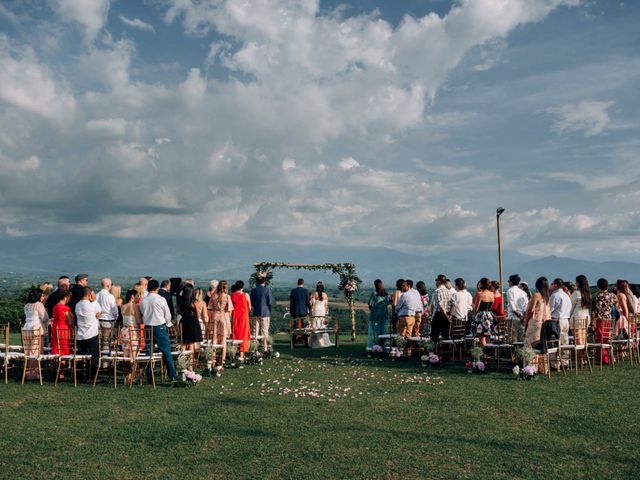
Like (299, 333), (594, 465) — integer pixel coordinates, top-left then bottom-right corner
(0, 337), (640, 479)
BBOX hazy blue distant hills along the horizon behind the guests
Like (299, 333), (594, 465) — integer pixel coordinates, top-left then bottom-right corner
(0, 236), (640, 286)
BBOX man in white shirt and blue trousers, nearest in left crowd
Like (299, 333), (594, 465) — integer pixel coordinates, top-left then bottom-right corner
(140, 279), (176, 381)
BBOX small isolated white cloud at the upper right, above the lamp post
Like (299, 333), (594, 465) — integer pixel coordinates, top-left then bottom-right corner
(547, 100), (615, 137)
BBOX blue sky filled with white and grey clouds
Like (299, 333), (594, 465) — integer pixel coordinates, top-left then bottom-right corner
(0, 0), (640, 261)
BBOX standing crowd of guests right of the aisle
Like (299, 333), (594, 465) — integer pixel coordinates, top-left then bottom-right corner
(367, 274), (640, 363)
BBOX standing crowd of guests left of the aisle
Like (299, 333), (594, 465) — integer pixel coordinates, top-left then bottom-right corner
(22, 274), (273, 380)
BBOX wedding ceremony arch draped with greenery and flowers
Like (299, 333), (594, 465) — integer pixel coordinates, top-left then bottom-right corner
(251, 262), (362, 340)
